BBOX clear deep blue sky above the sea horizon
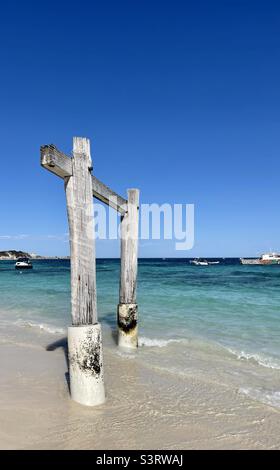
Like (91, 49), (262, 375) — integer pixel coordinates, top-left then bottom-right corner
(0, 0), (280, 256)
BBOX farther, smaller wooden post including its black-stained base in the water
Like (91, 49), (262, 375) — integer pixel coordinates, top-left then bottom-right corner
(118, 189), (139, 349)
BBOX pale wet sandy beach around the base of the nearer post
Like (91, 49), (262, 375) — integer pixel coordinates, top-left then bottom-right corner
(0, 322), (280, 450)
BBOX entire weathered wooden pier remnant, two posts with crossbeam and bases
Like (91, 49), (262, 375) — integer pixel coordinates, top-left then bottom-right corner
(41, 137), (139, 406)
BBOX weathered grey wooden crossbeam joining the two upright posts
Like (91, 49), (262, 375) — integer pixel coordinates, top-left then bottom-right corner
(40, 145), (127, 215)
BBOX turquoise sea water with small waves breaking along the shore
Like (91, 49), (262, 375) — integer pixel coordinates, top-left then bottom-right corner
(0, 259), (280, 406)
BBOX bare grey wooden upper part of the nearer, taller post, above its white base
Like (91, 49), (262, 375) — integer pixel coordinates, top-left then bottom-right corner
(65, 137), (97, 325)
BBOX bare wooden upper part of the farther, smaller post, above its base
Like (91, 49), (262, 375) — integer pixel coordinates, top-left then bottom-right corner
(120, 189), (139, 304)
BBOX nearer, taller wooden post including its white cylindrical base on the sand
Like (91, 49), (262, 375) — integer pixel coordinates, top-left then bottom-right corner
(65, 137), (105, 406)
